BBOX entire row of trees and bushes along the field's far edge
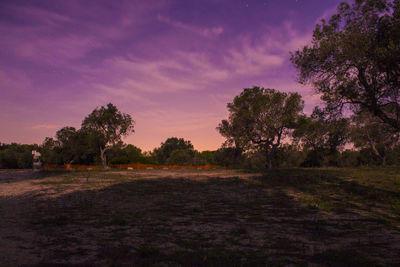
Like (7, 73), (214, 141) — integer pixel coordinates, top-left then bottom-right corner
(0, 99), (400, 170)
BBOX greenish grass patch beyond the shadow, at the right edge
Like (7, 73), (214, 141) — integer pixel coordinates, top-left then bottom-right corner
(262, 167), (400, 225)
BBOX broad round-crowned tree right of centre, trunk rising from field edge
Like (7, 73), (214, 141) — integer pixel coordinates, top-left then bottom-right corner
(217, 87), (303, 168)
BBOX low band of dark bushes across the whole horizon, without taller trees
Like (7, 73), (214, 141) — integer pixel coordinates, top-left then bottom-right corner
(0, 137), (400, 170)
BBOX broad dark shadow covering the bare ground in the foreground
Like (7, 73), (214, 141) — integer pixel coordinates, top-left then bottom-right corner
(0, 173), (400, 266)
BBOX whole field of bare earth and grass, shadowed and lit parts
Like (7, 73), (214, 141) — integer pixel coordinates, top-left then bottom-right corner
(0, 168), (400, 266)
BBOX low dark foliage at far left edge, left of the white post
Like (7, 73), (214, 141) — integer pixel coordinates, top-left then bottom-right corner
(0, 143), (38, 169)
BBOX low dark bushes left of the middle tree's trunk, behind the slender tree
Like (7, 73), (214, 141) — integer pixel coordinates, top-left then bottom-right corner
(0, 138), (256, 169)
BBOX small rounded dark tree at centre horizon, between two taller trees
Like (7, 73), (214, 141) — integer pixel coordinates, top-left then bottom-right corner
(154, 137), (195, 165)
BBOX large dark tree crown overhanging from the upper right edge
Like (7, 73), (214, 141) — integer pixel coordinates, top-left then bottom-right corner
(291, 0), (400, 132)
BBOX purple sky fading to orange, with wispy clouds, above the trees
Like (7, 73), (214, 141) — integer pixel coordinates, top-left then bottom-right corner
(0, 0), (341, 150)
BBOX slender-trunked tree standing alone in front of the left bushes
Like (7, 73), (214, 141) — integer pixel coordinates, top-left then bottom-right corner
(81, 103), (135, 167)
